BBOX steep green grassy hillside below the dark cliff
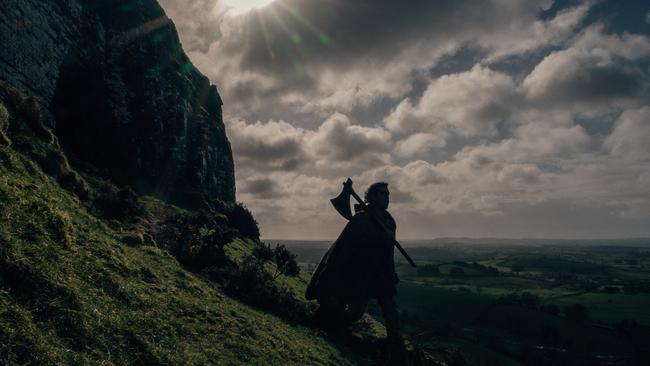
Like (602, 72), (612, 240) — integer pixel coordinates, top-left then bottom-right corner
(0, 98), (368, 365)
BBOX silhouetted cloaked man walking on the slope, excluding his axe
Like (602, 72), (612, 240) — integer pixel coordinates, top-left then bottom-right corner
(306, 182), (404, 353)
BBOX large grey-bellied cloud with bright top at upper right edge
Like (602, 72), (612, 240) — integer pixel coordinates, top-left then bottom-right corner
(522, 25), (650, 108)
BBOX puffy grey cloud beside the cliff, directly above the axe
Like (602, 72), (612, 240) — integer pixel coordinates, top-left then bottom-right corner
(228, 113), (393, 179)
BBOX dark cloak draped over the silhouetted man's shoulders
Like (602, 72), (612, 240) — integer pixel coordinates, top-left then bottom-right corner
(305, 211), (399, 300)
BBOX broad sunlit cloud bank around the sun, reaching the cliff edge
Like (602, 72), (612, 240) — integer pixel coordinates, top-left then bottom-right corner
(163, 0), (557, 117)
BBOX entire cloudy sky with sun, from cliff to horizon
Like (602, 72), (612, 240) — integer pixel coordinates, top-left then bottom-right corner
(160, 0), (650, 240)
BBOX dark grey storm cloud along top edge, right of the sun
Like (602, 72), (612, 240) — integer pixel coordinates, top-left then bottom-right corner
(233, 0), (541, 75)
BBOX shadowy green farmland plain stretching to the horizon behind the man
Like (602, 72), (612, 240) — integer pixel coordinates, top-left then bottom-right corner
(284, 239), (650, 365)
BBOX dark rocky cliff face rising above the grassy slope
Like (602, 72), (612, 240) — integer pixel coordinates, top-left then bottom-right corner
(0, 0), (235, 206)
